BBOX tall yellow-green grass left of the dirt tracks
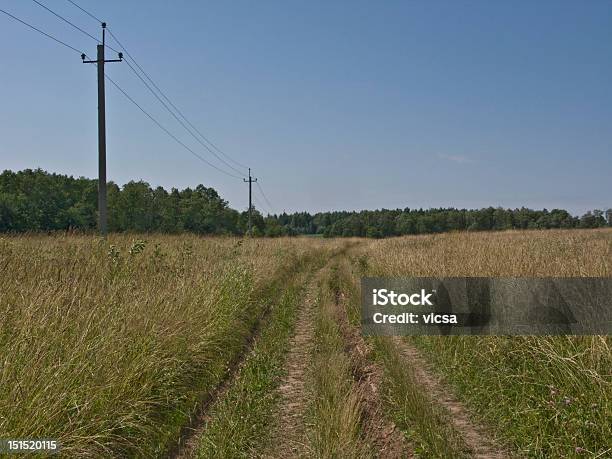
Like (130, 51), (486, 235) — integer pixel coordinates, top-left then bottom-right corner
(0, 235), (333, 457)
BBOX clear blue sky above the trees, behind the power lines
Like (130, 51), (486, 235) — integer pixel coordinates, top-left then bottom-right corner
(0, 0), (612, 213)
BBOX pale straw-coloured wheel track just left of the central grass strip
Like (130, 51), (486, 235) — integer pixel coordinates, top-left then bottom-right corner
(264, 271), (322, 458)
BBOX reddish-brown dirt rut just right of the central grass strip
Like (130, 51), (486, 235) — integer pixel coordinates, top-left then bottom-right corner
(334, 291), (414, 459)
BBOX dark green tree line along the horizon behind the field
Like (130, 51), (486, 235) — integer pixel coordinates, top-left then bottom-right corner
(0, 169), (612, 238)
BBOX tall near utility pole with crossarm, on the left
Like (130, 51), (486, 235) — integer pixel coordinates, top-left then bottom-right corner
(81, 22), (123, 236)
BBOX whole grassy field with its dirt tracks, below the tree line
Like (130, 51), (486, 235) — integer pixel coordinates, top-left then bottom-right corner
(0, 230), (612, 458)
